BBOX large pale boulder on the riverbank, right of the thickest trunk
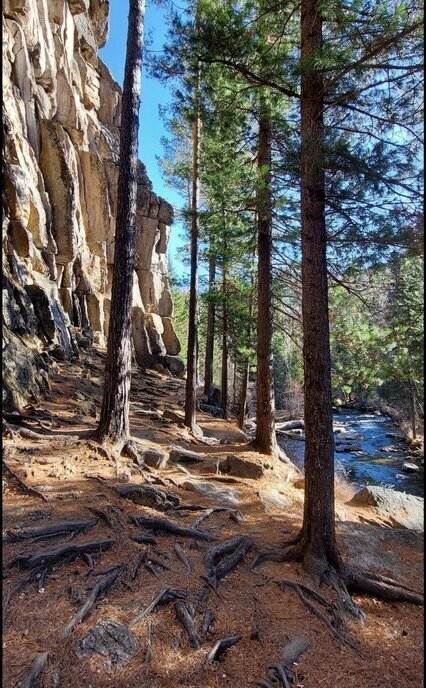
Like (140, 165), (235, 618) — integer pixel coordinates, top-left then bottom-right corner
(348, 486), (424, 531)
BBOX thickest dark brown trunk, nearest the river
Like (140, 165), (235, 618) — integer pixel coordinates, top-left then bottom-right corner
(301, 0), (336, 559)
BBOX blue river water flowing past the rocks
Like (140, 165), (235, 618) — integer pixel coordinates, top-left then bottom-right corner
(278, 411), (424, 497)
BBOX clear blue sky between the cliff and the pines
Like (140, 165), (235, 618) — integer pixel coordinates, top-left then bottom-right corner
(99, 0), (187, 277)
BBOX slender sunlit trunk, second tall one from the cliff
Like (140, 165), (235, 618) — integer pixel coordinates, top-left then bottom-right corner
(185, 30), (200, 432)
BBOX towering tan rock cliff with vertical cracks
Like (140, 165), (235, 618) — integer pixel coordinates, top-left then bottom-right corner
(2, 0), (180, 406)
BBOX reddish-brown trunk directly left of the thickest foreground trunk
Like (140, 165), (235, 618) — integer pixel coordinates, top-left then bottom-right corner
(255, 104), (277, 454)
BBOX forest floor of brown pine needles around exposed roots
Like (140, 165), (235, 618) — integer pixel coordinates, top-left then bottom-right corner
(3, 349), (423, 688)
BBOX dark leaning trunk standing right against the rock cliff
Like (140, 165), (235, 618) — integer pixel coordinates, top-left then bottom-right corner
(98, 0), (145, 444)
